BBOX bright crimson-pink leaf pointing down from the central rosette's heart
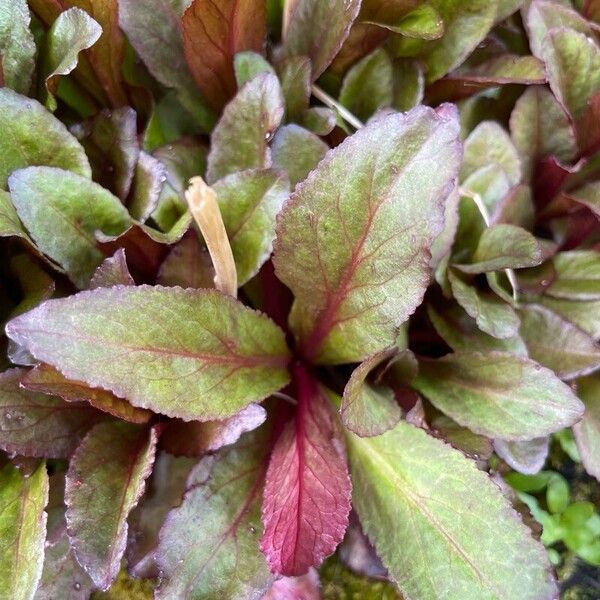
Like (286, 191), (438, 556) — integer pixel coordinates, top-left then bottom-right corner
(260, 366), (351, 575)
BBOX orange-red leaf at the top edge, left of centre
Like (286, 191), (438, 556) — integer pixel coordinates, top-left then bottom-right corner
(182, 0), (266, 110)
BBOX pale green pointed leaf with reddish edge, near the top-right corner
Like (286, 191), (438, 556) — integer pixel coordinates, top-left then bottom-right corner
(542, 29), (600, 121)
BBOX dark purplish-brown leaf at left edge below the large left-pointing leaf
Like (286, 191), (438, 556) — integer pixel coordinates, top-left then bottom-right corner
(0, 369), (101, 458)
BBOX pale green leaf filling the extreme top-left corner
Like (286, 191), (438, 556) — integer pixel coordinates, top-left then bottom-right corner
(0, 0), (36, 94)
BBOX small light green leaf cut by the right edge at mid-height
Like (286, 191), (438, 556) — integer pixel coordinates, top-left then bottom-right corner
(545, 250), (600, 300)
